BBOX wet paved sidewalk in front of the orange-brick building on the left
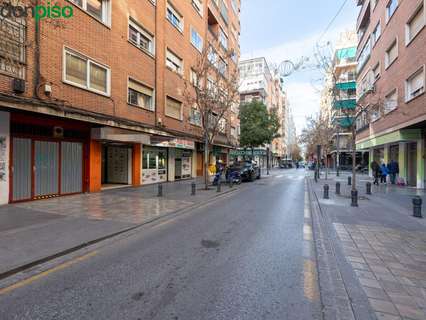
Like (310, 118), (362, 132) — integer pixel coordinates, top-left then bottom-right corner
(0, 179), (244, 277)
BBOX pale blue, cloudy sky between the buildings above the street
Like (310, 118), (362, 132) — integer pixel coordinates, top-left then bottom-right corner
(240, 0), (358, 134)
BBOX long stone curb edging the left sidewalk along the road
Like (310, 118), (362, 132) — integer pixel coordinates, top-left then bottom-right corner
(0, 188), (242, 281)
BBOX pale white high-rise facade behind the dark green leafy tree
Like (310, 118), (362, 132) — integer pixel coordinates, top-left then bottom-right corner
(239, 57), (286, 166)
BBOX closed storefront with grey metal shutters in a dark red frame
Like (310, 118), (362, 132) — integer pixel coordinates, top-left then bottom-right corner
(9, 114), (90, 202)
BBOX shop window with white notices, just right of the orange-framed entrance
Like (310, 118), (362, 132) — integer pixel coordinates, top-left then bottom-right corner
(142, 146), (167, 184)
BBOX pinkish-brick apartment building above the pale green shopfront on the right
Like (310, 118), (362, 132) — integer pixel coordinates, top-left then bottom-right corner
(357, 0), (426, 188)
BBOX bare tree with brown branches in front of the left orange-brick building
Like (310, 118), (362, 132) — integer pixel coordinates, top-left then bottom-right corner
(184, 44), (239, 189)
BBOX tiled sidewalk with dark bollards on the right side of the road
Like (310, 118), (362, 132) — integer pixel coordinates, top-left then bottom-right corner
(309, 173), (426, 320)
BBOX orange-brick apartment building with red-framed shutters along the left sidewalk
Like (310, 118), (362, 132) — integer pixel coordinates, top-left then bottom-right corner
(0, 0), (240, 204)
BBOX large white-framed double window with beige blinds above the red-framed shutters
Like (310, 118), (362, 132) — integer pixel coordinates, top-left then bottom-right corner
(63, 49), (110, 95)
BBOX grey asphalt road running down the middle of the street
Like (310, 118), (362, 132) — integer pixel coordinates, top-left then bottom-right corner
(0, 170), (321, 320)
